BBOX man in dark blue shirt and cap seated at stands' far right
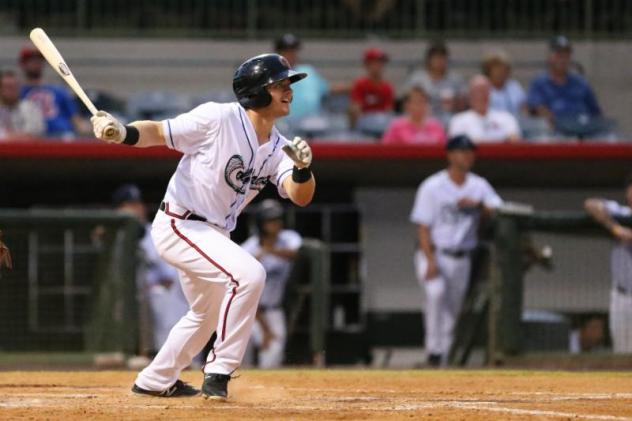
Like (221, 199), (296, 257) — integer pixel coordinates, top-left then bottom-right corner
(527, 36), (611, 137)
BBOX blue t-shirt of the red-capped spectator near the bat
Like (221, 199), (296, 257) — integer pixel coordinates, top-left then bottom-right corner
(20, 85), (77, 137)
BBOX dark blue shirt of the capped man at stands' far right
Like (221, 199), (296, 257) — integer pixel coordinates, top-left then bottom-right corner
(527, 73), (601, 118)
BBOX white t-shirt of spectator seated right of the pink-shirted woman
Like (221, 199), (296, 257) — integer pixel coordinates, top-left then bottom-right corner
(448, 110), (520, 143)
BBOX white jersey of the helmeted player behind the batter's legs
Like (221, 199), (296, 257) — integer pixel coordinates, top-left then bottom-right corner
(241, 230), (303, 308)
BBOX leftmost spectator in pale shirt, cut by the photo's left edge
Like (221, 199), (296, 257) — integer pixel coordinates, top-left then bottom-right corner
(0, 70), (44, 141)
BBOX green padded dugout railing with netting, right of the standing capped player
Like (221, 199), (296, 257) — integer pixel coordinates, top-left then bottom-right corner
(451, 212), (632, 368)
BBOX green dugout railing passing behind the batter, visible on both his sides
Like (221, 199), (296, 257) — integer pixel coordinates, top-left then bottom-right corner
(0, 209), (331, 366)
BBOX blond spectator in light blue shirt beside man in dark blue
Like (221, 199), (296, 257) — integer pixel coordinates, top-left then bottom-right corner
(482, 51), (527, 118)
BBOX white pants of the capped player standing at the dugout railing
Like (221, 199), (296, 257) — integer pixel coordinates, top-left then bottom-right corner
(415, 250), (471, 359)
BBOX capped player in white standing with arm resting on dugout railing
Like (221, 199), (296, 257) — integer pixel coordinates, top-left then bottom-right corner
(410, 135), (502, 366)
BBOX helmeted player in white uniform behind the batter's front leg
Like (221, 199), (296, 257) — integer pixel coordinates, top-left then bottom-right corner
(241, 199), (303, 368)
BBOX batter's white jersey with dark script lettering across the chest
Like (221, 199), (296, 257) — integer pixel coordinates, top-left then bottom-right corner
(162, 102), (294, 231)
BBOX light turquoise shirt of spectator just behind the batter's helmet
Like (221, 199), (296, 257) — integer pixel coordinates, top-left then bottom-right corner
(290, 64), (329, 118)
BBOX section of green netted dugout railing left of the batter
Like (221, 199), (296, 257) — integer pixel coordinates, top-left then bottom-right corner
(0, 210), (142, 353)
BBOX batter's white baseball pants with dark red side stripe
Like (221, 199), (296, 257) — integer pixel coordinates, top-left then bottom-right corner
(136, 208), (266, 391)
